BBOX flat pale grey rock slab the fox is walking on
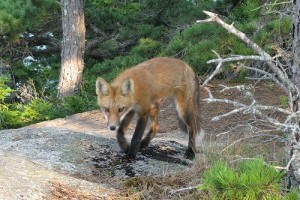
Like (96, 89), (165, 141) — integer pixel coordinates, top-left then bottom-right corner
(0, 111), (192, 200)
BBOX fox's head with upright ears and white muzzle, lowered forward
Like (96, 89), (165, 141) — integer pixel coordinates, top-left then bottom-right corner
(96, 77), (134, 131)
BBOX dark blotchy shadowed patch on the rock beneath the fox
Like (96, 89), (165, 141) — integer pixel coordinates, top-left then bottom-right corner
(92, 141), (192, 177)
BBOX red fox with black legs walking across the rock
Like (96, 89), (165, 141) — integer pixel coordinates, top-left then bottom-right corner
(96, 57), (200, 159)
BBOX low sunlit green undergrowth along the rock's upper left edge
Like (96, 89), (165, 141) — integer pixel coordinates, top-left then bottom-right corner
(0, 76), (96, 129)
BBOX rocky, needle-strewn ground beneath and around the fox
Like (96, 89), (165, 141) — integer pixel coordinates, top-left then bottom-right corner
(0, 82), (285, 200)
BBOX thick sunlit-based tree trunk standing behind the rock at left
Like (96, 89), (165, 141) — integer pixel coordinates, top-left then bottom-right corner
(58, 0), (85, 99)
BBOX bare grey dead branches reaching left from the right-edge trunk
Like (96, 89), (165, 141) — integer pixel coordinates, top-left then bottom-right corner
(197, 11), (299, 134)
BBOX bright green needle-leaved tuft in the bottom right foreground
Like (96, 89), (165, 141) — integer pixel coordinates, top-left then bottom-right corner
(198, 159), (283, 200)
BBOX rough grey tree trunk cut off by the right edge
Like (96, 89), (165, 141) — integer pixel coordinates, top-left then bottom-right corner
(290, 0), (300, 187)
